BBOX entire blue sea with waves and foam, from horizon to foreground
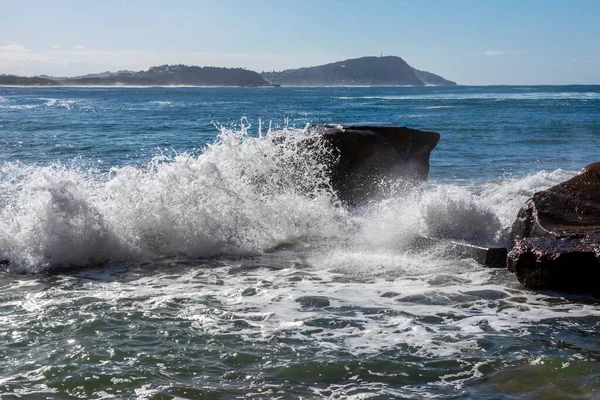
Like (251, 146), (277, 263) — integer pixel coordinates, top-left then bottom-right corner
(0, 86), (600, 400)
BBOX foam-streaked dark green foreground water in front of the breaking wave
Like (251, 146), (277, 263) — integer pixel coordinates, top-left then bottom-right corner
(0, 251), (600, 398)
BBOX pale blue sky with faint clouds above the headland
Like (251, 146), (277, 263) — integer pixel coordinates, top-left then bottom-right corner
(0, 0), (600, 85)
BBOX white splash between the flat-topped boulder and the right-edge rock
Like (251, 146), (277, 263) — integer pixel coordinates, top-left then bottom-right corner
(309, 170), (573, 278)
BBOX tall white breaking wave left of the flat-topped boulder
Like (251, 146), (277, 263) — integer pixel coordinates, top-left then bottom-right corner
(0, 128), (346, 271)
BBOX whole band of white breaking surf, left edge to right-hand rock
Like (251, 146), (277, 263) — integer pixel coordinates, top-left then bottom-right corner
(0, 128), (569, 275)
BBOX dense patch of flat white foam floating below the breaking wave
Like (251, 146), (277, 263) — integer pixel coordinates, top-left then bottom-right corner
(15, 264), (600, 362)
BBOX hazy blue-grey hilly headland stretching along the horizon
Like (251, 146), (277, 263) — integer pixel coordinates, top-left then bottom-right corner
(0, 56), (456, 87)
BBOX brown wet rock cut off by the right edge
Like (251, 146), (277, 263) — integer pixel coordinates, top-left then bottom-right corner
(507, 163), (600, 293)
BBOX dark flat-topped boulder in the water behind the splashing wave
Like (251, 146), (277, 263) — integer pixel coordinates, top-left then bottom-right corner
(310, 125), (440, 204)
